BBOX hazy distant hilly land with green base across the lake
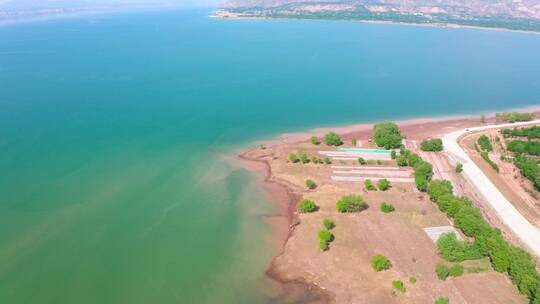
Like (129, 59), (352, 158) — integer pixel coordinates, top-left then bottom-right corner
(218, 0), (540, 31)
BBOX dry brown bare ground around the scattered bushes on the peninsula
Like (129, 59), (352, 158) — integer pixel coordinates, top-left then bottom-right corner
(246, 123), (526, 304)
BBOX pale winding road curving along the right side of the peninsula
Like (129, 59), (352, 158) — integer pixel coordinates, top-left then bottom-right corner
(442, 120), (540, 257)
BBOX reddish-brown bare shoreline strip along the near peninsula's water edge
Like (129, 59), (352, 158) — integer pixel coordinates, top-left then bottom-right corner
(237, 106), (540, 303)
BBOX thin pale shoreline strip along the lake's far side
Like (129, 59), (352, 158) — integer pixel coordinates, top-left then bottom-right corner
(209, 11), (540, 35)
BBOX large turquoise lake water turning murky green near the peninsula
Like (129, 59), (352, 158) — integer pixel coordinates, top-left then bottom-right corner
(0, 10), (540, 304)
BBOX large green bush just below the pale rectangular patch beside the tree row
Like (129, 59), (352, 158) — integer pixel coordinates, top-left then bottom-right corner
(437, 232), (482, 262)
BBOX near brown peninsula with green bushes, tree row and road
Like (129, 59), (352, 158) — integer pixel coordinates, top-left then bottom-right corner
(241, 113), (540, 304)
